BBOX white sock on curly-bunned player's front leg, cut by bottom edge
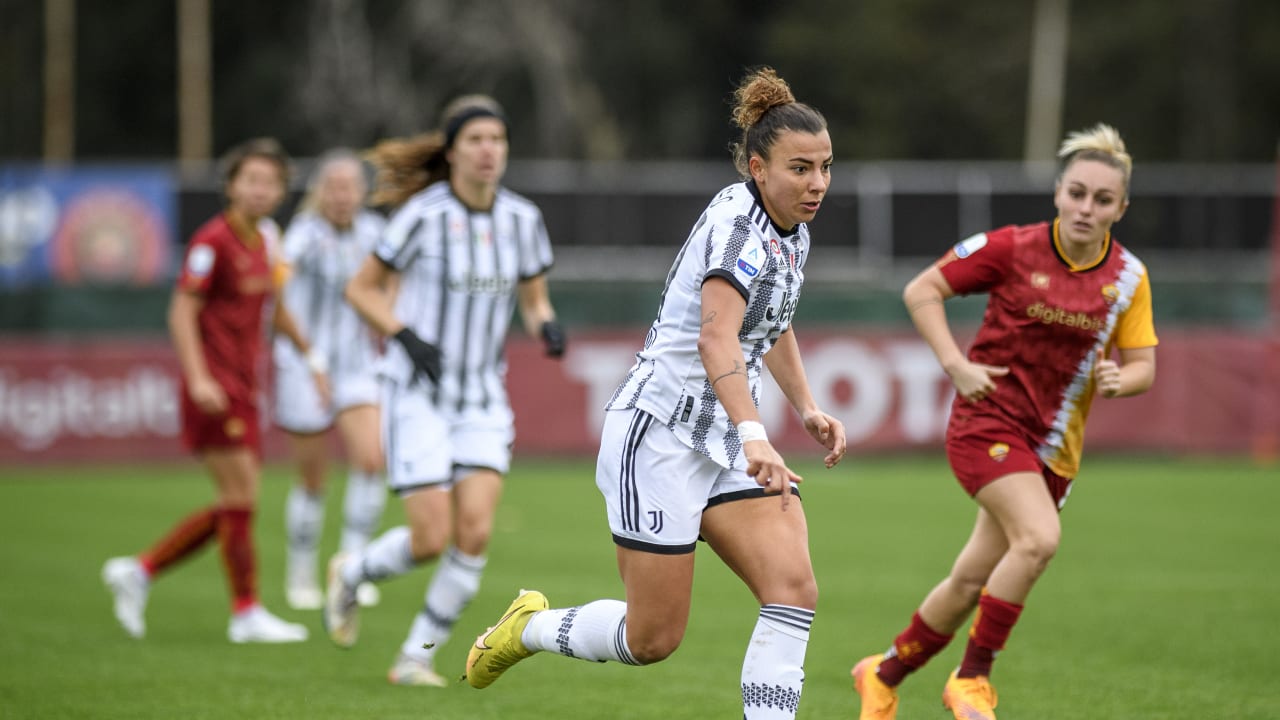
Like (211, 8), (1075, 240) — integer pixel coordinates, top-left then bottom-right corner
(742, 605), (813, 720)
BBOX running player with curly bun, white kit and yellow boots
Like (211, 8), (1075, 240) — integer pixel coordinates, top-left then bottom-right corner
(466, 68), (845, 720)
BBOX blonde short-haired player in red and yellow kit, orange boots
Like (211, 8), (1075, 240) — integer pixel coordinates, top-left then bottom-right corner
(852, 124), (1156, 720)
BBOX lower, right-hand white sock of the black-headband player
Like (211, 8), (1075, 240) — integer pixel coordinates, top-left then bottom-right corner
(401, 547), (485, 662)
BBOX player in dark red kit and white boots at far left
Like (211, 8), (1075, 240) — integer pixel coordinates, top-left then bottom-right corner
(102, 138), (328, 643)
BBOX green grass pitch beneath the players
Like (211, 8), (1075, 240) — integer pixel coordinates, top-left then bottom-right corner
(0, 455), (1280, 720)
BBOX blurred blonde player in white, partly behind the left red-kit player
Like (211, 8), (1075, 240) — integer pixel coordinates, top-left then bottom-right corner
(273, 149), (387, 610)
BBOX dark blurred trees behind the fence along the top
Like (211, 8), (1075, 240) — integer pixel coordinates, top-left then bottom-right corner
(0, 0), (1280, 161)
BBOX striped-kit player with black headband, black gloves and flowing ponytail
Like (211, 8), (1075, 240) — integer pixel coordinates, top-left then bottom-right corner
(325, 95), (564, 685)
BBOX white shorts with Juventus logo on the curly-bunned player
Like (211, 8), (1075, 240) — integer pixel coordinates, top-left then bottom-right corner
(595, 410), (795, 555)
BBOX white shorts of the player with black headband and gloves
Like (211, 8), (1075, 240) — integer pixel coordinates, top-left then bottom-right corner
(383, 380), (516, 495)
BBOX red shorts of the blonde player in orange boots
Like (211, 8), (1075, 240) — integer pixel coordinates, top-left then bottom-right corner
(947, 424), (1071, 510)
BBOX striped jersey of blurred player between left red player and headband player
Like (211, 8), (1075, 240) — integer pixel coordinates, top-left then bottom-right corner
(274, 210), (387, 378)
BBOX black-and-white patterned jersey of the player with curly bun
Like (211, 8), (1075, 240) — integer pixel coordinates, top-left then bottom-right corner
(605, 182), (809, 469)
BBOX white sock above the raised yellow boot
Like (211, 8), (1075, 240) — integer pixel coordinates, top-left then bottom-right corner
(520, 600), (640, 665)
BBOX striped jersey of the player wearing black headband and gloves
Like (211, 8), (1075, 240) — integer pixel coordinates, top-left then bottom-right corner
(375, 181), (552, 413)
